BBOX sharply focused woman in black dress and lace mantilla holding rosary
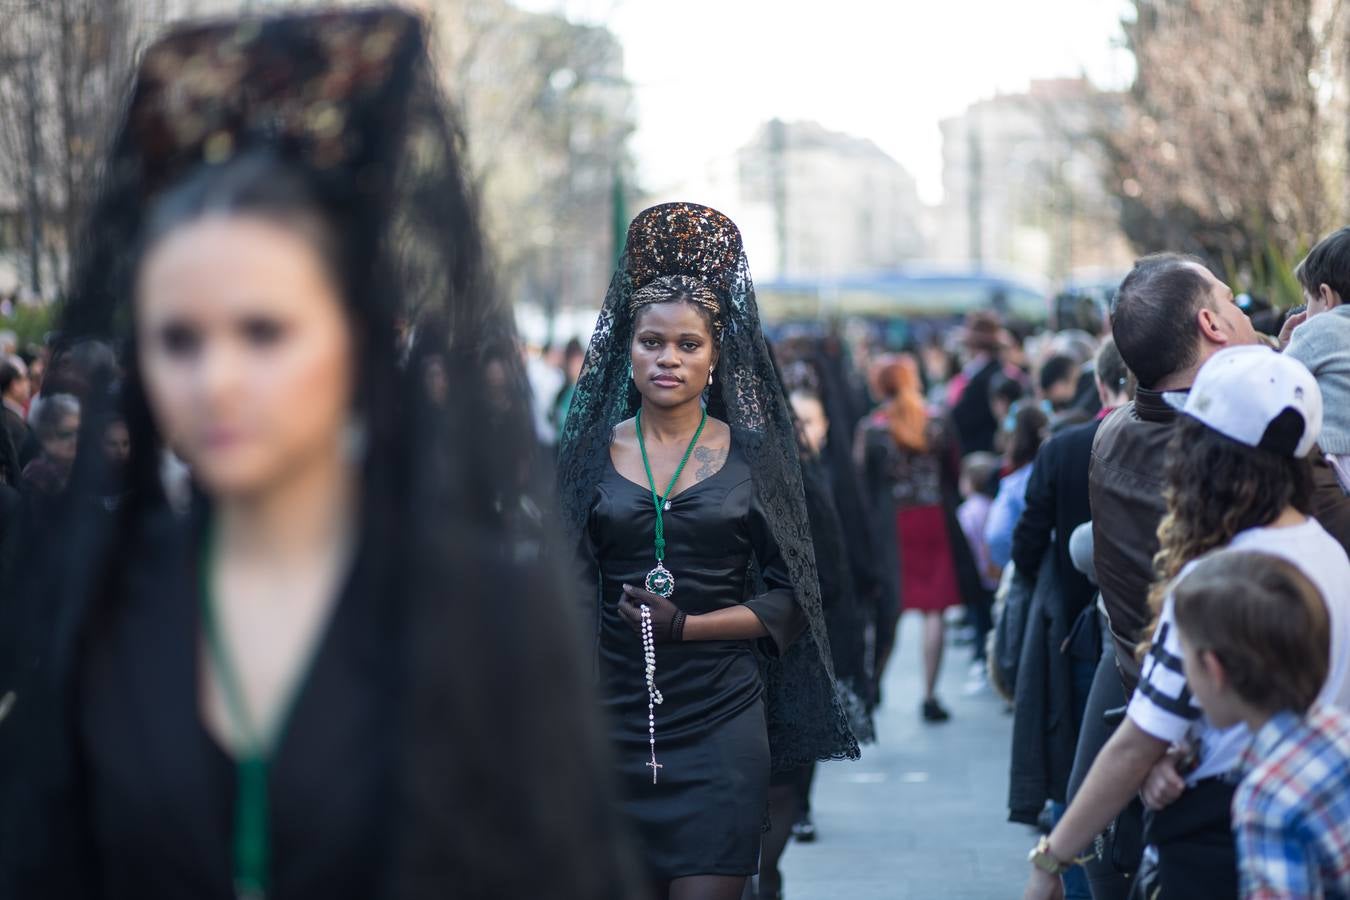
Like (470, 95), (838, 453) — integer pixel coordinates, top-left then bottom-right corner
(559, 204), (857, 900)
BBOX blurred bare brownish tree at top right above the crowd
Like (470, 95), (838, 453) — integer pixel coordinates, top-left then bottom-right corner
(1098, 0), (1343, 300)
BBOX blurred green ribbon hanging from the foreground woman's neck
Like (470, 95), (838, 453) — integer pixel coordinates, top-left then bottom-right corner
(201, 529), (317, 900)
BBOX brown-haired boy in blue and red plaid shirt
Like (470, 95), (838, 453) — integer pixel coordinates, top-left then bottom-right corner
(1175, 551), (1350, 900)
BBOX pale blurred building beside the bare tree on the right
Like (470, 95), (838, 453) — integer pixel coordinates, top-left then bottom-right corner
(932, 78), (1134, 281)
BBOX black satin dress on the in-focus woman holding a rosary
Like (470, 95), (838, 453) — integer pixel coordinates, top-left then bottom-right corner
(587, 443), (805, 881)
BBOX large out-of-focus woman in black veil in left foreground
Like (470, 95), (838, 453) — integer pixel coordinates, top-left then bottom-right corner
(0, 8), (641, 900)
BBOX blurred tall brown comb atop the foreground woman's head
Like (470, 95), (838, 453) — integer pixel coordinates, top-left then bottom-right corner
(120, 8), (423, 192)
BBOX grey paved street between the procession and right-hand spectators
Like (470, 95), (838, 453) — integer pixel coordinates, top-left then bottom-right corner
(783, 615), (1034, 900)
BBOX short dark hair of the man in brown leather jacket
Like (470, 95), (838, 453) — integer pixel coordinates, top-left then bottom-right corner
(1111, 254), (1208, 389)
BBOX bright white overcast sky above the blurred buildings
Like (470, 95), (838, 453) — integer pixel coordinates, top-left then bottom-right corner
(517, 0), (1131, 202)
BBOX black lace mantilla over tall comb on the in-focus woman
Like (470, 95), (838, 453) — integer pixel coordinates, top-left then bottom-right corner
(559, 204), (859, 772)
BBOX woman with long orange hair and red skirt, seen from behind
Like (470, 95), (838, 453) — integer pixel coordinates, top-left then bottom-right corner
(856, 355), (969, 722)
